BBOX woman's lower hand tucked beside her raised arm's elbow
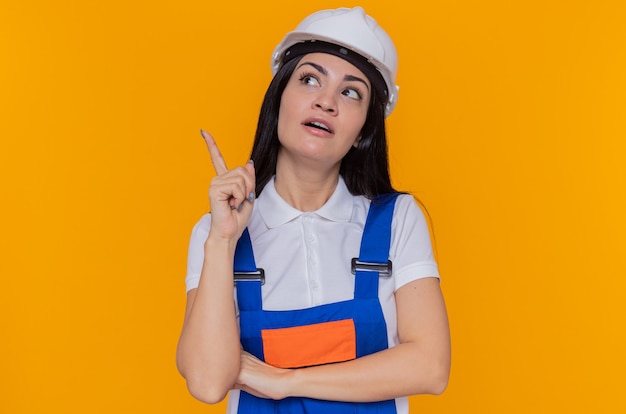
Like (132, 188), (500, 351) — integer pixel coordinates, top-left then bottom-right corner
(235, 350), (293, 400)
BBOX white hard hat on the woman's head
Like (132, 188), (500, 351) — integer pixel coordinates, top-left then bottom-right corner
(272, 6), (399, 116)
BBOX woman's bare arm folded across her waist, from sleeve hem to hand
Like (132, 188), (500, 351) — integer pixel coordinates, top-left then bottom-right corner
(237, 278), (450, 402)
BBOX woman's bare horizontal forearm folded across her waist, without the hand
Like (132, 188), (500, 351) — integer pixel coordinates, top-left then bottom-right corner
(283, 343), (450, 402)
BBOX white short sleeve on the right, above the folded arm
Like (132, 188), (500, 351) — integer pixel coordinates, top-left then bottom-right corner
(389, 194), (439, 290)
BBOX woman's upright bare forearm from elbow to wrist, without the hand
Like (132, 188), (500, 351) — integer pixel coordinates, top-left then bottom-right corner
(177, 238), (240, 403)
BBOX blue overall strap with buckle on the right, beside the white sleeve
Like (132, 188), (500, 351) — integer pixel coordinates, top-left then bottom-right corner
(352, 193), (398, 299)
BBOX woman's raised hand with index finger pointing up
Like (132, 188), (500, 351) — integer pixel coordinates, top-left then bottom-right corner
(200, 130), (255, 241)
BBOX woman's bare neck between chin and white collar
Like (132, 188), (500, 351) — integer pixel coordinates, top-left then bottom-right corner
(275, 157), (339, 211)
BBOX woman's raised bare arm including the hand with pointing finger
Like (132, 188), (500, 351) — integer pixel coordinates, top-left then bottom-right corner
(176, 130), (254, 403)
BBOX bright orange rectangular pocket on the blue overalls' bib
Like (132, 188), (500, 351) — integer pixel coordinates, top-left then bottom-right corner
(261, 319), (356, 368)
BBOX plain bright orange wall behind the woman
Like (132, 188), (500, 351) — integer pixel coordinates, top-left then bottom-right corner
(0, 0), (626, 414)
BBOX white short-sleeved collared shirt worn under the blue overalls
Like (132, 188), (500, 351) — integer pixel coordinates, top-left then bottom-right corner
(185, 177), (439, 412)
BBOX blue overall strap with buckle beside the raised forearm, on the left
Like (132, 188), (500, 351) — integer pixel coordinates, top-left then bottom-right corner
(234, 228), (263, 311)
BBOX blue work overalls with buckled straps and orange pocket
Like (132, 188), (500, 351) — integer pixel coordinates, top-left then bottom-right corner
(235, 194), (397, 414)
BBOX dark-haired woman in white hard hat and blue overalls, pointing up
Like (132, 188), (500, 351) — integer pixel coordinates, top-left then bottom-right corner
(177, 7), (450, 413)
